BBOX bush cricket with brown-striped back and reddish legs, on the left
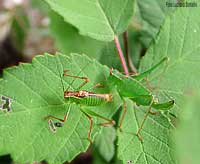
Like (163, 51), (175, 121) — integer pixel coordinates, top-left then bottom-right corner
(45, 67), (115, 143)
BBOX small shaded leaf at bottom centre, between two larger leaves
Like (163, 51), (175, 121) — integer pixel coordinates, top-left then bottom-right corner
(95, 127), (116, 162)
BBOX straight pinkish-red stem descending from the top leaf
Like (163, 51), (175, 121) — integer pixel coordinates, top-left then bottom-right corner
(114, 36), (129, 75)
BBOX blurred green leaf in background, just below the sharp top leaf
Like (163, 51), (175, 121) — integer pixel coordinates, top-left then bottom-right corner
(49, 11), (104, 58)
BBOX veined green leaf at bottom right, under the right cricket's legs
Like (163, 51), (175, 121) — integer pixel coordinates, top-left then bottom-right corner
(118, 100), (176, 164)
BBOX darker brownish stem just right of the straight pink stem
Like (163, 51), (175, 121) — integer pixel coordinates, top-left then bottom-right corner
(123, 31), (137, 74)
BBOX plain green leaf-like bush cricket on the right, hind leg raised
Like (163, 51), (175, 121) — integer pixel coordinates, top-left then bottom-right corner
(108, 57), (174, 141)
